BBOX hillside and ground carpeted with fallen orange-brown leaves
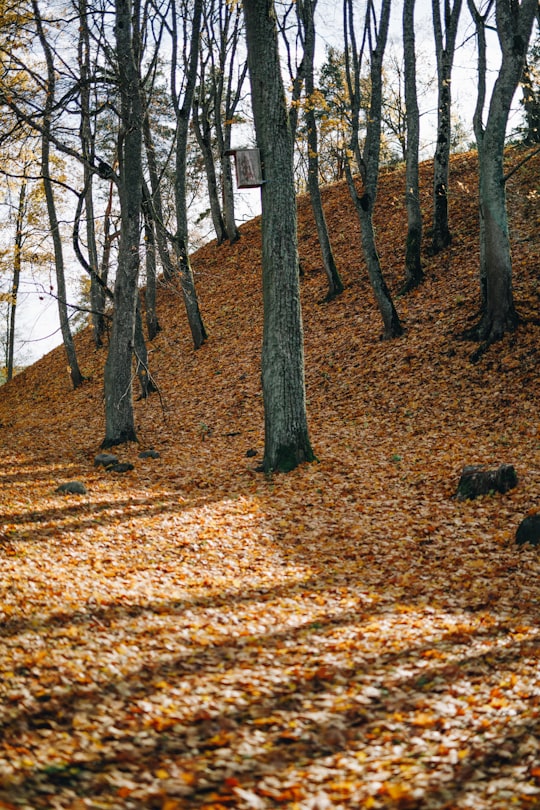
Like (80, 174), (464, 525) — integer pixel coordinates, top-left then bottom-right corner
(0, 151), (540, 810)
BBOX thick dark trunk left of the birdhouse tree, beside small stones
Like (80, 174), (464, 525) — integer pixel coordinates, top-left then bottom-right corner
(102, 0), (143, 448)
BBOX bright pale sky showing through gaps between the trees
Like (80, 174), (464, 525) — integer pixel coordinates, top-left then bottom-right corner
(0, 3), (538, 368)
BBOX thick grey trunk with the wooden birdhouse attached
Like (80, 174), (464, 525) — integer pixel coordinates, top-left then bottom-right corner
(244, 0), (314, 471)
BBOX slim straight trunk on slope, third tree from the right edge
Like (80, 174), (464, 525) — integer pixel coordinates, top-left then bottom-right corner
(401, 0), (424, 293)
